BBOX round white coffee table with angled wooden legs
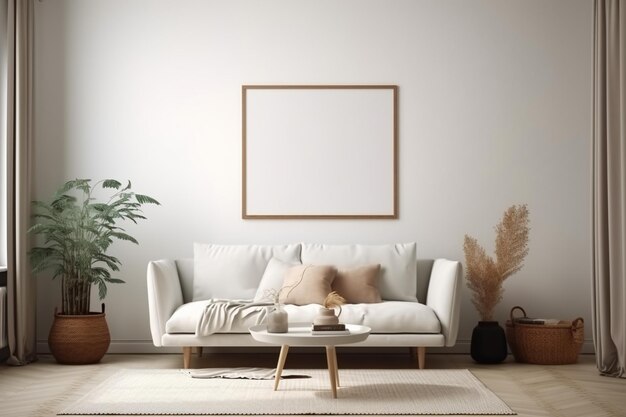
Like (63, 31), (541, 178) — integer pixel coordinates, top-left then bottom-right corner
(250, 323), (371, 398)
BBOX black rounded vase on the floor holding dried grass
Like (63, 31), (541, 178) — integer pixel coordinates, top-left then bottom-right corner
(471, 321), (507, 363)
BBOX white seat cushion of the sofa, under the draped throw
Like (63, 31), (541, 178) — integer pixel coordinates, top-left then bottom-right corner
(165, 300), (441, 334)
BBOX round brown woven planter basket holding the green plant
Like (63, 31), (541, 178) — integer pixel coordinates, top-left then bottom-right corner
(48, 304), (111, 365)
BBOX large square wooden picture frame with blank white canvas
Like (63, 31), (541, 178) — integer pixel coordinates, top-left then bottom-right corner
(242, 85), (398, 219)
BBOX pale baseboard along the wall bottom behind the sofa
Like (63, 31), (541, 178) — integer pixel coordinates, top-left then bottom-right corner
(37, 340), (595, 355)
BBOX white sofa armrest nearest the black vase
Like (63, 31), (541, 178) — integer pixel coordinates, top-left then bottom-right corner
(426, 259), (463, 346)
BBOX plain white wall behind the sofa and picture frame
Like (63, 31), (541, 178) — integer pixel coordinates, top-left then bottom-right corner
(35, 0), (592, 351)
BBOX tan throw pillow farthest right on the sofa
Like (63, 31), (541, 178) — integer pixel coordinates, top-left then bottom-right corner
(332, 264), (382, 304)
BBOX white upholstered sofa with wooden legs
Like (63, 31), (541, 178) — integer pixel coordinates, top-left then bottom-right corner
(147, 243), (462, 368)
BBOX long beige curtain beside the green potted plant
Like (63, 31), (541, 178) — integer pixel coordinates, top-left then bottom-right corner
(0, 0), (36, 365)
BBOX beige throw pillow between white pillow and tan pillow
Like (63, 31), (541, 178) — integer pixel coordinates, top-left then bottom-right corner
(280, 265), (337, 305)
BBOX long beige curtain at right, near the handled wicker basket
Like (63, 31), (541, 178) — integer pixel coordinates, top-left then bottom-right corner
(592, 0), (626, 378)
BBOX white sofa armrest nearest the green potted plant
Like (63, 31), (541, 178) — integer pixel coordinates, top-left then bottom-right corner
(148, 259), (183, 346)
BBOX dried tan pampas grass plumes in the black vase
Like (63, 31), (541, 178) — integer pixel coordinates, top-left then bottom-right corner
(463, 204), (530, 321)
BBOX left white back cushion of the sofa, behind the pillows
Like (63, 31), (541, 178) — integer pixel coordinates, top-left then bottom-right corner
(193, 243), (301, 301)
